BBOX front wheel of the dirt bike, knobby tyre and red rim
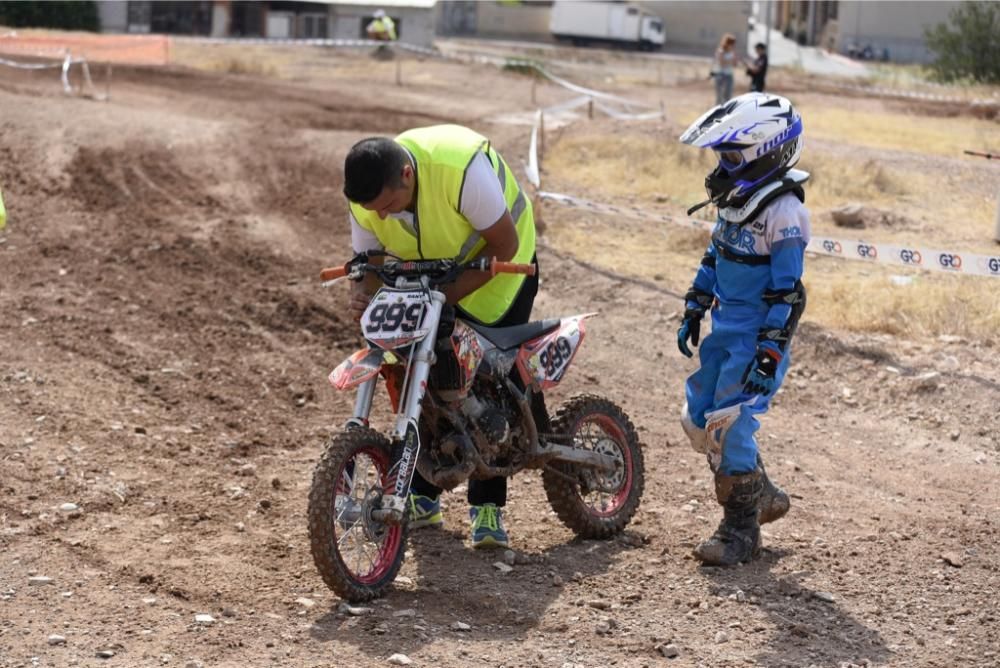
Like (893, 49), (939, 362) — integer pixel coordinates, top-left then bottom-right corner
(308, 427), (406, 603)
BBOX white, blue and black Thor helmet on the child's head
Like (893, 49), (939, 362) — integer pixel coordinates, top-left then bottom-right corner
(680, 93), (802, 209)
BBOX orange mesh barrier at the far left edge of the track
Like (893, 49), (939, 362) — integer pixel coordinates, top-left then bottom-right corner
(0, 33), (170, 65)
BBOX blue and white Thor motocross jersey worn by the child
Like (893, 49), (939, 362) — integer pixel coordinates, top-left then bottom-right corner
(688, 193), (810, 329)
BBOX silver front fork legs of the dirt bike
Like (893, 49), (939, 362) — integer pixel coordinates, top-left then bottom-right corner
(348, 290), (445, 524)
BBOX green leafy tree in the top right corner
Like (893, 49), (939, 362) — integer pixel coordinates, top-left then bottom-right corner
(924, 0), (1000, 84)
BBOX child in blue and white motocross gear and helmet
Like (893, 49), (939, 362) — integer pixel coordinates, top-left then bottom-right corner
(677, 93), (809, 565)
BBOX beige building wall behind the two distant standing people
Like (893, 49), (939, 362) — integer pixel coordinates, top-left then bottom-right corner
(637, 0), (752, 56)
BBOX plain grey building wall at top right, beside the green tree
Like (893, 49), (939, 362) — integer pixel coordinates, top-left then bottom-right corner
(836, 0), (952, 63)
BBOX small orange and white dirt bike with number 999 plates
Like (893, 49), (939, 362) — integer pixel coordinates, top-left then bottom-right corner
(308, 251), (644, 602)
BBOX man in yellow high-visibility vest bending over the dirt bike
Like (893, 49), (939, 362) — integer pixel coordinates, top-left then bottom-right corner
(344, 125), (538, 548)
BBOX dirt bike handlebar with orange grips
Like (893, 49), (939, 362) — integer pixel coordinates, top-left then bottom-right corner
(319, 252), (535, 285)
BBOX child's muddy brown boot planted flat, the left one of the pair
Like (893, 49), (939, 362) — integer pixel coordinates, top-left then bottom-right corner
(694, 469), (764, 566)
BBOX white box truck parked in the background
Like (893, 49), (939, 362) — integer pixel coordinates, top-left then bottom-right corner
(549, 0), (664, 51)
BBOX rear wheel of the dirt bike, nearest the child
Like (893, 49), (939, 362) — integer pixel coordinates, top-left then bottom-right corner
(542, 395), (645, 538)
